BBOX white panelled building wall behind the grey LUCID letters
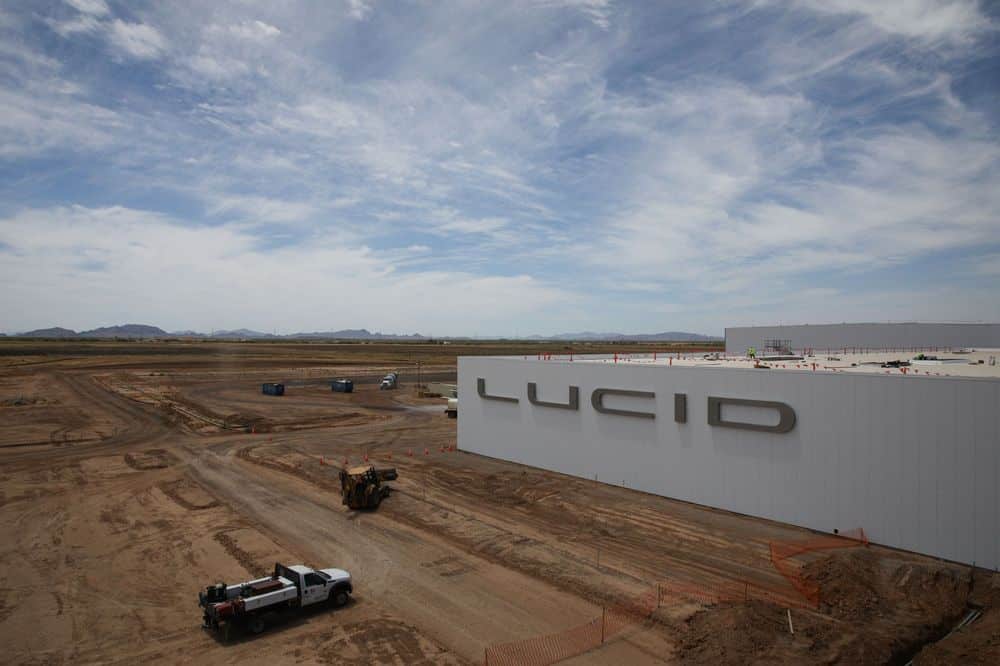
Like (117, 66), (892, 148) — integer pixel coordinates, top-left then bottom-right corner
(458, 357), (1000, 568)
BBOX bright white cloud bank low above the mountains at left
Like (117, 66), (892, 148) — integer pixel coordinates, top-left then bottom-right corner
(0, 206), (573, 334)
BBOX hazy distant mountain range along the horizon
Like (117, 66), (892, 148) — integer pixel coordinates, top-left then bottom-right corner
(12, 324), (722, 342)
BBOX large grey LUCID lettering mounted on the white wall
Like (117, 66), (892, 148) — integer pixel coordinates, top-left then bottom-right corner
(476, 377), (795, 433)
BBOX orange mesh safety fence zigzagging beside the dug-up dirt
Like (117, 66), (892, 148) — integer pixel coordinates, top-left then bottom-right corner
(484, 528), (868, 666)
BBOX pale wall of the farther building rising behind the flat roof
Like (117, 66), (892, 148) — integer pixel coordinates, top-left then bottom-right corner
(726, 323), (1000, 354)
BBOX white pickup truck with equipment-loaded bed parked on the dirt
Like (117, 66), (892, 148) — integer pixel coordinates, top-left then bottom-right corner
(198, 563), (354, 638)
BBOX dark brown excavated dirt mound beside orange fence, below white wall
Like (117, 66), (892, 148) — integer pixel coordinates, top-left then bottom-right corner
(677, 548), (972, 664)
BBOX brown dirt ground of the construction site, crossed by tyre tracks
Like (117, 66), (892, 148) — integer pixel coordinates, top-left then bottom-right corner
(0, 341), (1000, 664)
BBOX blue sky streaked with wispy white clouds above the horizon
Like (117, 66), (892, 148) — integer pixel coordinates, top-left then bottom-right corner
(0, 0), (1000, 336)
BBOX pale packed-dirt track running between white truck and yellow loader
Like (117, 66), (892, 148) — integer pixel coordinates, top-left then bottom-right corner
(177, 438), (594, 661)
